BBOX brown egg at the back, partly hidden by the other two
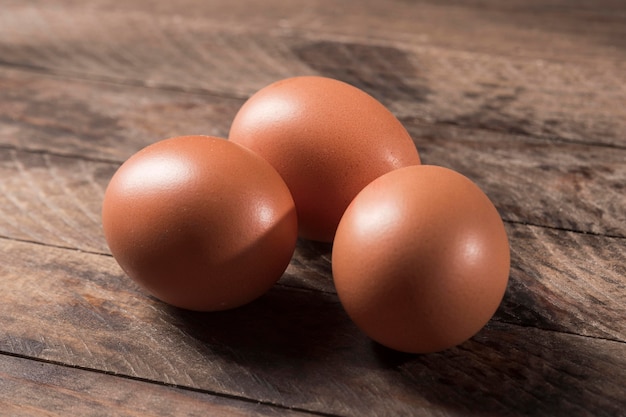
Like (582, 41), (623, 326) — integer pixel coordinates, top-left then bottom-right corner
(229, 76), (420, 241)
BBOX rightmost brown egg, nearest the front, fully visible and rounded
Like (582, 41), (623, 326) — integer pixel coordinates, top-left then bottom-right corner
(332, 165), (510, 353)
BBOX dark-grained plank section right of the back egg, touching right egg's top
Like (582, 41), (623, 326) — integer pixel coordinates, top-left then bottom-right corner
(406, 123), (626, 237)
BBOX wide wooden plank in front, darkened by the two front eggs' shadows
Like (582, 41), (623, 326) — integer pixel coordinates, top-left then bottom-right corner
(0, 237), (626, 416)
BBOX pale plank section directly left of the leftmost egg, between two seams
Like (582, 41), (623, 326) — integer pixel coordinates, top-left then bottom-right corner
(0, 149), (111, 253)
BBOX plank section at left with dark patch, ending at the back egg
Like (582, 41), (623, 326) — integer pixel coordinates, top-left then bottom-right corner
(0, 68), (242, 162)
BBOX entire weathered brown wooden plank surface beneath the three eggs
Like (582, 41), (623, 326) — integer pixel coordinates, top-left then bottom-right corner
(0, 0), (626, 417)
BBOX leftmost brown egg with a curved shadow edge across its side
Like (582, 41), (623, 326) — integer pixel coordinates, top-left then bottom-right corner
(102, 136), (297, 311)
